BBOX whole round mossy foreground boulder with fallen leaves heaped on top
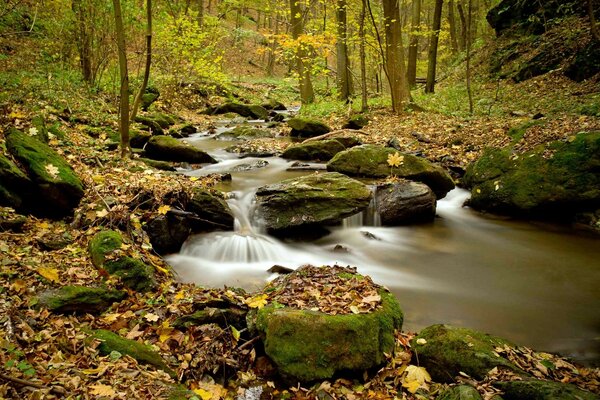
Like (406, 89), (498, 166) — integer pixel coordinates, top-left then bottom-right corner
(250, 267), (403, 382)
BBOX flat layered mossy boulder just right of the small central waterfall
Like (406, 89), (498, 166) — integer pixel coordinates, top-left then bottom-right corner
(256, 172), (371, 234)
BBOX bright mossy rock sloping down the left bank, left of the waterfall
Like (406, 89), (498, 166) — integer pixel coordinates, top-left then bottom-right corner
(89, 231), (156, 292)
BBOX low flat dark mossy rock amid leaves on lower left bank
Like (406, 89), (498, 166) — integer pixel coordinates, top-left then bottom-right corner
(37, 285), (127, 314)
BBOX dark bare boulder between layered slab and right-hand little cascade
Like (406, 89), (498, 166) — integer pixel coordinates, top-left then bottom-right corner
(375, 179), (436, 226)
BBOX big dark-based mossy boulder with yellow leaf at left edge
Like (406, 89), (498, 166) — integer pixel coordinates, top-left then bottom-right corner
(5, 128), (84, 218)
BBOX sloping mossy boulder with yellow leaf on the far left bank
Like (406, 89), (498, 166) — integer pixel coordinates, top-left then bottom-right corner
(6, 128), (84, 218)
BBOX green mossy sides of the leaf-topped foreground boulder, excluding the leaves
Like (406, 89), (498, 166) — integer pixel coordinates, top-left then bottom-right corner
(255, 290), (403, 382)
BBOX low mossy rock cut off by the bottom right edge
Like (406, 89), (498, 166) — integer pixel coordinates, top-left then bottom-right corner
(493, 379), (600, 400)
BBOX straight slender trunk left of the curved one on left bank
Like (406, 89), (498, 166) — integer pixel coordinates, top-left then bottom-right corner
(113, 0), (131, 158)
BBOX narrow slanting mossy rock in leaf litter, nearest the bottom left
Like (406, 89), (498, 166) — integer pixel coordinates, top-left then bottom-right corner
(91, 329), (176, 378)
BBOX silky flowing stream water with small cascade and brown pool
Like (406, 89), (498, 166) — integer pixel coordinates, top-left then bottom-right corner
(167, 125), (600, 365)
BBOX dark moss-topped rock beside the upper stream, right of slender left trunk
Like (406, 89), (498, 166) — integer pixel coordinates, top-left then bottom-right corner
(146, 136), (217, 164)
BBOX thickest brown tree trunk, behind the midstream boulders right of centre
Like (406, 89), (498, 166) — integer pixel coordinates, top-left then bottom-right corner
(383, 0), (410, 114)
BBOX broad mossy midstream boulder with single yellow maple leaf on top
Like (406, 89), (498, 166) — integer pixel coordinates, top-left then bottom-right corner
(327, 145), (454, 199)
